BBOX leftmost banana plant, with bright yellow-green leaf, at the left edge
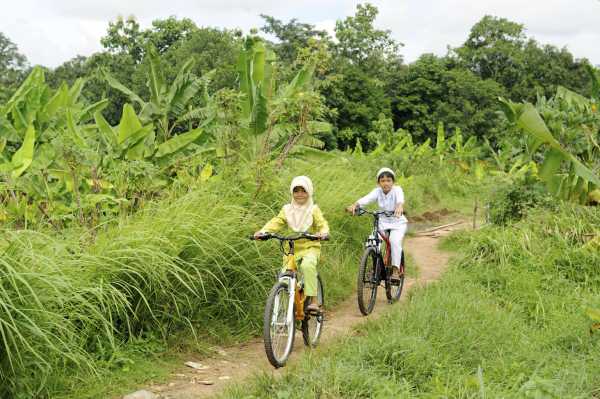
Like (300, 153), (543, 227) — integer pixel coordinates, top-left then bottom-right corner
(0, 67), (107, 227)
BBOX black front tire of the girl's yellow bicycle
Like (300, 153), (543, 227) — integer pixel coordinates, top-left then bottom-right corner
(263, 281), (296, 368)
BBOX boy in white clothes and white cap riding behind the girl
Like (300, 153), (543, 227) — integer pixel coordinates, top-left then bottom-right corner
(347, 168), (408, 275)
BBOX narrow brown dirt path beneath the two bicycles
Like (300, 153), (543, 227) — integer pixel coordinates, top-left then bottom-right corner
(142, 224), (465, 399)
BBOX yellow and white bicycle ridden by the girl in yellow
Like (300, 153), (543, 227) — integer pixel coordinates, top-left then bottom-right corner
(250, 233), (329, 368)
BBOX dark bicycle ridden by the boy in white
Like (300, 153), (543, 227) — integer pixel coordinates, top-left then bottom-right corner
(356, 208), (405, 316)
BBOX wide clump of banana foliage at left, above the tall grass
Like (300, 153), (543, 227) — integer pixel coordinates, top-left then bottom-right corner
(0, 68), (213, 228)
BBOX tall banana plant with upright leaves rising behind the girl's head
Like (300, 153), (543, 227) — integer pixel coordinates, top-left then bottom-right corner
(237, 36), (331, 164)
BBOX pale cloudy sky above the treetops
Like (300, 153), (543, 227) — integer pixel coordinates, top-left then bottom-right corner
(0, 0), (600, 67)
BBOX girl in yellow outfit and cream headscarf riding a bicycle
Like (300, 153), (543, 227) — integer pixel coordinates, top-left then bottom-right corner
(254, 176), (329, 311)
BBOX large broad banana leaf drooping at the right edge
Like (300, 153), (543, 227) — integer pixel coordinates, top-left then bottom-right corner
(500, 95), (600, 203)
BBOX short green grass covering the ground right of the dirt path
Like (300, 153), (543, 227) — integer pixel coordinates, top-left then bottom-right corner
(224, 207), (600, 398)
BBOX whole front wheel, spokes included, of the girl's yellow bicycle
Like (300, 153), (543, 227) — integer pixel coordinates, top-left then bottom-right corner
(263, 281), (296, 368)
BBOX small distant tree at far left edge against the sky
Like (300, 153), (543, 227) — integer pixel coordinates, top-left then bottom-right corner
(0, 32), (27, 102)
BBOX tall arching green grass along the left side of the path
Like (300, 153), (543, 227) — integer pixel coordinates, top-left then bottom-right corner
(0, 156), (480, 398)
